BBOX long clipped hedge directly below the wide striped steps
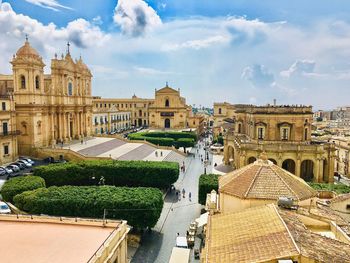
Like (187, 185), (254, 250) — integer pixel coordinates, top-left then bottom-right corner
(34, 160), (179, 189)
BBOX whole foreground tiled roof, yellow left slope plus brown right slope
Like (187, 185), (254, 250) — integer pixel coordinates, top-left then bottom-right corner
(202, 204), (350, 263)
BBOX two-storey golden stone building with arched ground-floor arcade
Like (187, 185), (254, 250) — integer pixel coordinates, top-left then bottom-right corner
(214, 103), (335, 182)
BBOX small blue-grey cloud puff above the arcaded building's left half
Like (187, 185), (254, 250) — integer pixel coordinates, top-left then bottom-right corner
(241, 64), (275, 87)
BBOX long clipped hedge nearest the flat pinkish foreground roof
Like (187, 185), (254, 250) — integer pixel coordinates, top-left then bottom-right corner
(14, 186), (163, 231)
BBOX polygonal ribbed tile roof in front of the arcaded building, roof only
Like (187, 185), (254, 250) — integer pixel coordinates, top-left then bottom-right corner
(219, 160), (317, 200)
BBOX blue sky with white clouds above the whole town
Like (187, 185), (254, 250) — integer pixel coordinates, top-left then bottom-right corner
(0, 0), (350, 110)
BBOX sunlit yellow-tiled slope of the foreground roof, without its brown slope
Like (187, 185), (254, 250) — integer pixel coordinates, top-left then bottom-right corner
(202, 205), (299, 263)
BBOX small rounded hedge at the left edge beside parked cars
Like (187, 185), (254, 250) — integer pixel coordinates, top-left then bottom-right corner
(1, 175), (45, 202)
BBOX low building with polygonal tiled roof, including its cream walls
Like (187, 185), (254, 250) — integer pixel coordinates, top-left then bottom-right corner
(219, 157), (317, 213)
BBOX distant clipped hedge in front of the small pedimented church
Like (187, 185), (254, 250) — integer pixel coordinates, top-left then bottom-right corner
(128, 132), (197, 147)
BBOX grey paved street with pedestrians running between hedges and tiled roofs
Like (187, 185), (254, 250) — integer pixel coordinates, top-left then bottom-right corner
(131, 141), (211, 263)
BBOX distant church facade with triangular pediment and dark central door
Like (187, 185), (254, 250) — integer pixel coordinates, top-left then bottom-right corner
(149, 84), (192, 129)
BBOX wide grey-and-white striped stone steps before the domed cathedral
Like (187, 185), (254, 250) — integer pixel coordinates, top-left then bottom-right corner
(63, 137), (185, 163)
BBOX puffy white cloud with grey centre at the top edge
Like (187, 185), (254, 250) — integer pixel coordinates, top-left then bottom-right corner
(113, 0), (162, 36)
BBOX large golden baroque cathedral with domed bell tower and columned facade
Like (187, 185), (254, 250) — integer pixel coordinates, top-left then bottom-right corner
(0, 39), (92, 154)
